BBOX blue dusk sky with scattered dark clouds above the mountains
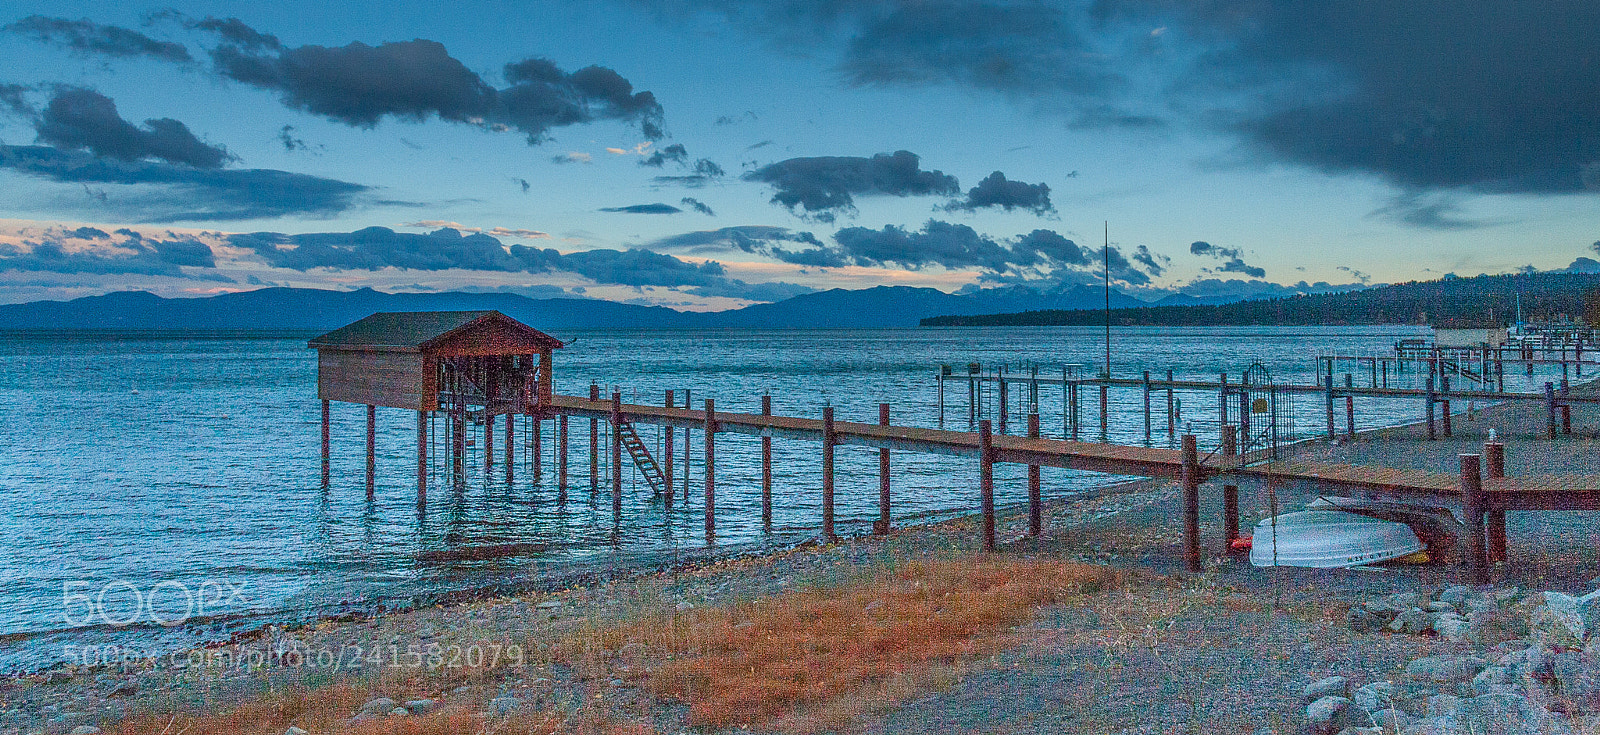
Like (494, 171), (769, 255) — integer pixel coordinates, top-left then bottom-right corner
(0, 0), (1600, 311)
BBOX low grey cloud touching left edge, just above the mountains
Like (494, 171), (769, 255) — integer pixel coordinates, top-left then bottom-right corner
(0, 227), (222, 282)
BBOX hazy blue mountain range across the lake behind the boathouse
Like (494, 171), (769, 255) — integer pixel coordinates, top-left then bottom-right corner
(0, 287), (1144, 330)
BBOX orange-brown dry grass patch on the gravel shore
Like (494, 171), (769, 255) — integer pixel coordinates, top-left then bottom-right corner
(562, 557), (1114, 732)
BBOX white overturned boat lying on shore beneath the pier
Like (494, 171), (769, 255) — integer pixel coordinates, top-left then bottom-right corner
(1250, 509), (1427, 568)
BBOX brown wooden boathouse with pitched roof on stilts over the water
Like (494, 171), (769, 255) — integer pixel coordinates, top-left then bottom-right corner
(307, 311), (563, 493)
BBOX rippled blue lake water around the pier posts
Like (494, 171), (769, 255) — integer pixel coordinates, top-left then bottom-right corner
(0, 327), (1548, 669)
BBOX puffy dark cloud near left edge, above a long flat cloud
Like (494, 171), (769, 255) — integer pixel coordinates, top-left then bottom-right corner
(35, 86), (234, 168)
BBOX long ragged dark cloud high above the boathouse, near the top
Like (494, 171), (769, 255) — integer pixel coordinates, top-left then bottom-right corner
(195, 19), (662, 144)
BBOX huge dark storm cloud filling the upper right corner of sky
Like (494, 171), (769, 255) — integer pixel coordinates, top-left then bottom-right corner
(1104, 0), (1600, 192)
